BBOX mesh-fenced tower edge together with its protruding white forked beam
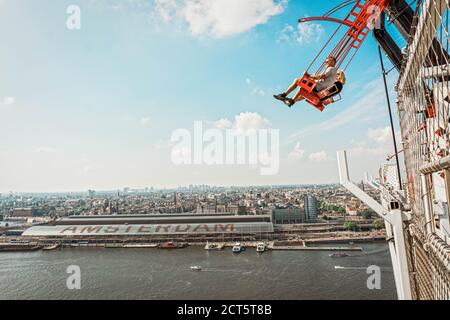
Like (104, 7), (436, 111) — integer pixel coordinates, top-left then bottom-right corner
(338, 0), (450, 300)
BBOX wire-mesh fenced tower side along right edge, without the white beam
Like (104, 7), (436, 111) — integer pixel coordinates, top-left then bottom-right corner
(397, 0), (450, 299)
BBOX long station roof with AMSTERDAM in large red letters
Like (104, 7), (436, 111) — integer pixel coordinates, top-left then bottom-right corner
(22, 214), (273, 237)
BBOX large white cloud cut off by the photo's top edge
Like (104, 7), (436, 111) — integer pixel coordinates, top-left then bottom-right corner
(154, 0), (287, 38)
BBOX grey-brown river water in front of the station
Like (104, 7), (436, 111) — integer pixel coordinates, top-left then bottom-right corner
(0, 243), (396, 299)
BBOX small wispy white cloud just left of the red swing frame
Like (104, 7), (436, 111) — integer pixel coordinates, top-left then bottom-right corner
(278, 22), (325, 44)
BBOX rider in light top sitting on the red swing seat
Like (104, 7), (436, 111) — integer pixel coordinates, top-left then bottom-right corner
(273, 57), (345, 107)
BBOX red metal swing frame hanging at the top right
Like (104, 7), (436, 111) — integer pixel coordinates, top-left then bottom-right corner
(298, 0), (389, 111)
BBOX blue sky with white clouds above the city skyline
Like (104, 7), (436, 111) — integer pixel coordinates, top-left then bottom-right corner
(0, 0), (402, 193)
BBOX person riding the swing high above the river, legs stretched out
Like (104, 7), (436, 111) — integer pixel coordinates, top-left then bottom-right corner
(273, 56), (338, 107)
